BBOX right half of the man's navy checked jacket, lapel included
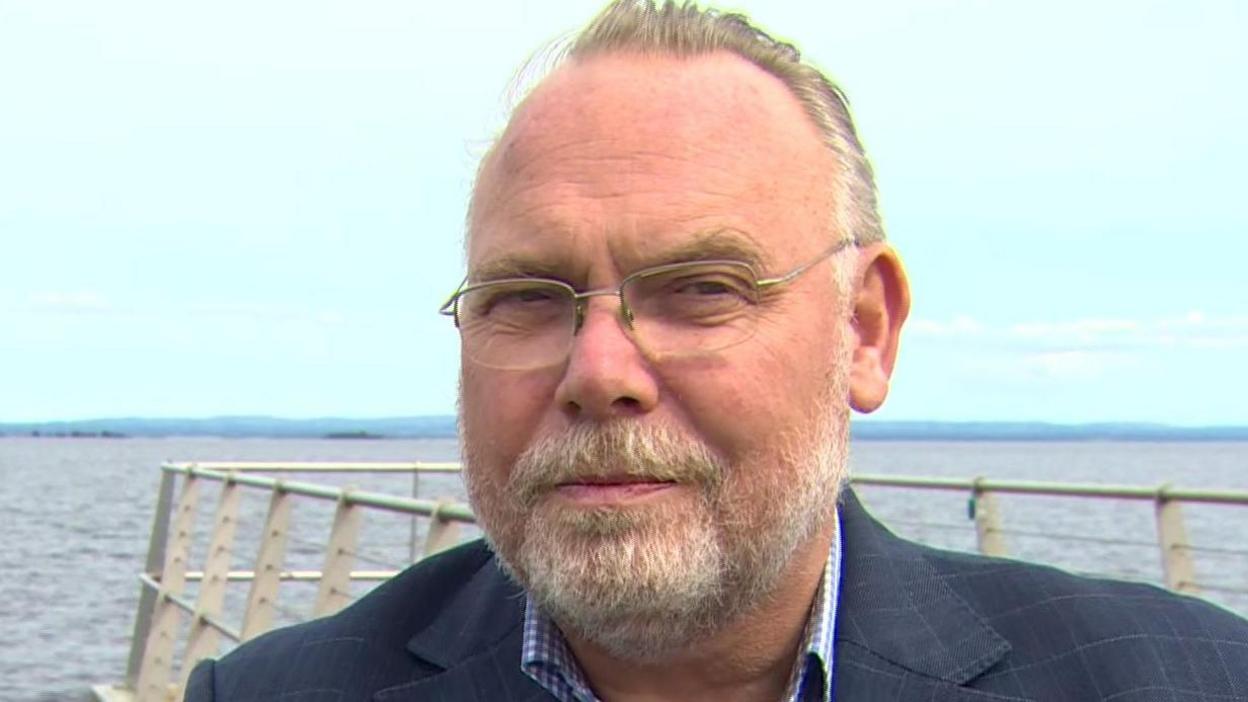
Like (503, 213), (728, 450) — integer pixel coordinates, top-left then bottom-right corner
(836, 491), (1248, 702)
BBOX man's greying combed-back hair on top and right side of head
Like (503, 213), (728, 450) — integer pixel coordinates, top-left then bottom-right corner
(565, 0), (884, 244)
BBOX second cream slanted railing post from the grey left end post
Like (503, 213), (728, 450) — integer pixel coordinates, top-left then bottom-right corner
(181, 476), (242, 688)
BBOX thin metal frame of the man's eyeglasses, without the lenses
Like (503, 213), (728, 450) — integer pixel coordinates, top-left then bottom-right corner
(438, 239), (857, 336)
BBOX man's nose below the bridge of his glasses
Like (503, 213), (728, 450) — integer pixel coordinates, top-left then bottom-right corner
(555, 297), (659, 420)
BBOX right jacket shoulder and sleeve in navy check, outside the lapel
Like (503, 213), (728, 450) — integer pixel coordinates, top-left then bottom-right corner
(926, 542), (1248, 700)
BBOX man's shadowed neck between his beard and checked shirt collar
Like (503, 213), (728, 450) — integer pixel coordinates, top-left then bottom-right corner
(565, 518), (836, 702)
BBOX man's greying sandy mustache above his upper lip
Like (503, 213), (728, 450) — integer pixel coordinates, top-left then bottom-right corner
(508, 421), (728, 507)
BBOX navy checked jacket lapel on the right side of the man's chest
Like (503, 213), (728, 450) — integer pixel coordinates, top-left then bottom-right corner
(832, 490), (1010, 701)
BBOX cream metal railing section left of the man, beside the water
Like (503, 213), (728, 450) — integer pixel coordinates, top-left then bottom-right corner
(95, 462), (474, 702)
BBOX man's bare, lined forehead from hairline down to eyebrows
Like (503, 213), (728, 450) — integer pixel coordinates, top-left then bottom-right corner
(469, 52), (835, 273)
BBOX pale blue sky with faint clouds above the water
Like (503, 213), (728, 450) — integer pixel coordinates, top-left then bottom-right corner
(0, 0), (1248, 425)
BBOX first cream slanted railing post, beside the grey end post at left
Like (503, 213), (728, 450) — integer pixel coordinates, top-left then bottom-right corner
(135, 472), (200, 702)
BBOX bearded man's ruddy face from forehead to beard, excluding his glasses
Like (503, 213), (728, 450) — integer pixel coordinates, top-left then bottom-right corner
(461, 50), (850, 657)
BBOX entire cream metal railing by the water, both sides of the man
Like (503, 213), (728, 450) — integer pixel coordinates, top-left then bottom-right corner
(95, 462), (1248, 702)
